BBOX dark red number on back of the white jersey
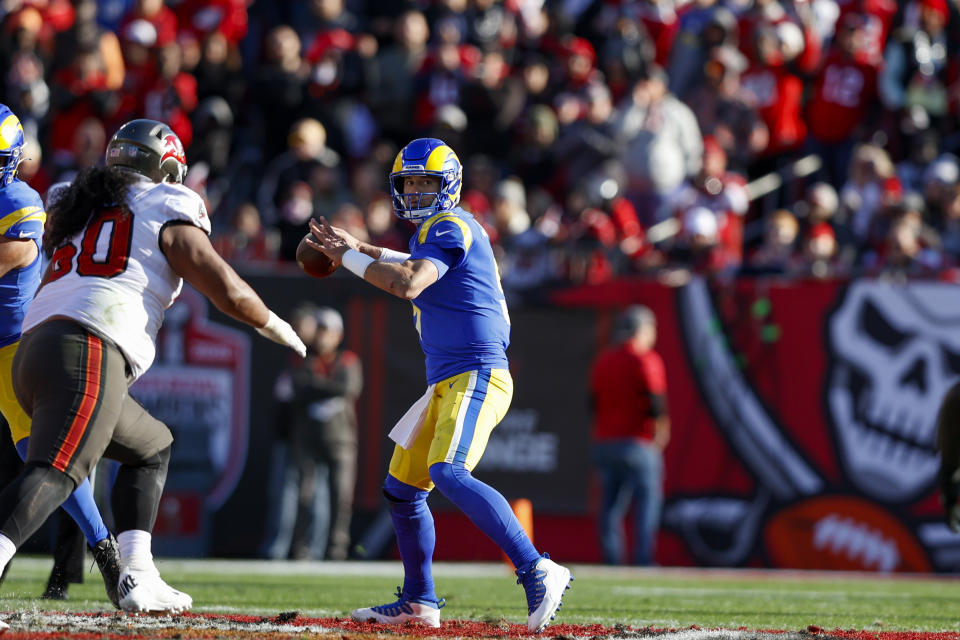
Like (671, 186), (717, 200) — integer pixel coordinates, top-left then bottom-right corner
(50, 208), (133, 282)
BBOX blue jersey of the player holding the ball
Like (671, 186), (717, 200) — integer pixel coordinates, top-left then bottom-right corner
(410, 208), (510, 384)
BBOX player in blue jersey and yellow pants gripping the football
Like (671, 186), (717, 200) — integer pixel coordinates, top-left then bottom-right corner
(306, 138), (573, 632)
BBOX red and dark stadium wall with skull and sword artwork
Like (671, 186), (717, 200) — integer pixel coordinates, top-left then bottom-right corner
(135, 274), (960, 571)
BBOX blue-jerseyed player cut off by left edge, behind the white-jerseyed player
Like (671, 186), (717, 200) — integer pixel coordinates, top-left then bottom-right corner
(0, 104), (120, 606)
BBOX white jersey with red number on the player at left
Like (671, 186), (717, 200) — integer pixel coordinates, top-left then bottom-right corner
(23, 179), (210, 379)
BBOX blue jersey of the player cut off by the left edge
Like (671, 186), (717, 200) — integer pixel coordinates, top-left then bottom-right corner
(0, 180), (47, 347)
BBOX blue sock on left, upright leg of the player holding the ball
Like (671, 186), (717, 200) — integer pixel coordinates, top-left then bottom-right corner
(383, 475), (437, 602)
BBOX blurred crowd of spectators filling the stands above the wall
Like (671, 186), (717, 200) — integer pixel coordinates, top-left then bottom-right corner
(0, 0), (960, 294)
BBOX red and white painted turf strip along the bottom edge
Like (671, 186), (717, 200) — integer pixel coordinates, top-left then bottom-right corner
(0, 611), (960, 640)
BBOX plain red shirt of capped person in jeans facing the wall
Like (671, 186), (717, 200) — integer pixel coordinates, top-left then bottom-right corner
(590, 308), (667, 440)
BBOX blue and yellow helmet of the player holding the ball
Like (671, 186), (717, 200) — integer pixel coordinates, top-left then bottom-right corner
(390, 138), (463, 221)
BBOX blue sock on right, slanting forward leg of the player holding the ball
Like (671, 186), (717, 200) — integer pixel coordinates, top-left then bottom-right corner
(430, 462), (540, 568)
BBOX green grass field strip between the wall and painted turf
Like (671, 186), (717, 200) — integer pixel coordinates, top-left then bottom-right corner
(0, 557), (960, 632)
